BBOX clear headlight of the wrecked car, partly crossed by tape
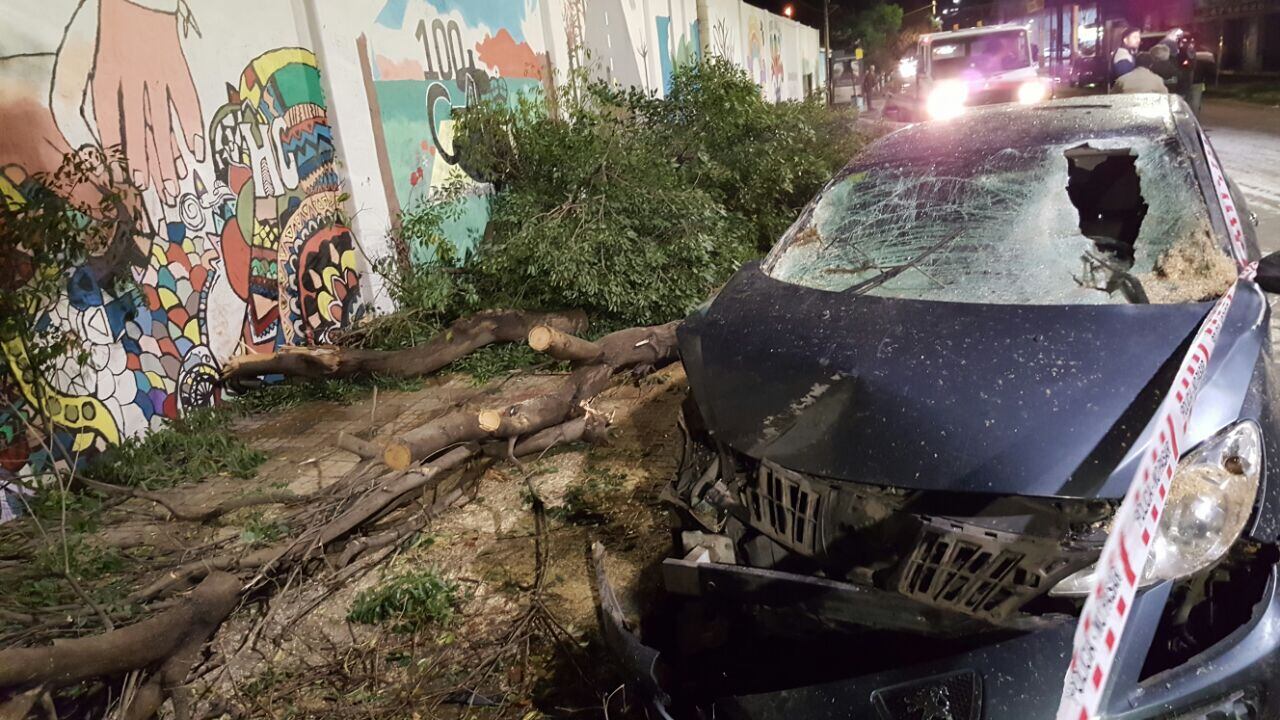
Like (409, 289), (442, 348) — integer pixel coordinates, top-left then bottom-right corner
(1050, 420), (1262, 596)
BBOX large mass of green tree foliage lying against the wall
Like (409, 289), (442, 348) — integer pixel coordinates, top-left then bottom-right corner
(456, 58), (859, 324)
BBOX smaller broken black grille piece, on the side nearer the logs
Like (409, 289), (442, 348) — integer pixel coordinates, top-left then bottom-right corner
(746, 462), (823, 555)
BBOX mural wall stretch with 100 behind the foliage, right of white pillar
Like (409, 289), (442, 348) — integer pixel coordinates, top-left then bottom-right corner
(356, 0), (822, 256)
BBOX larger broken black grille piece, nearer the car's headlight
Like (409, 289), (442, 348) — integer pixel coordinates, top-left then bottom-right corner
(899, 524), (1071, 620)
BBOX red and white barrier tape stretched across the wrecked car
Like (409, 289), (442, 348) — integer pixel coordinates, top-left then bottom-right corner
(1057, 131), (1257, 720)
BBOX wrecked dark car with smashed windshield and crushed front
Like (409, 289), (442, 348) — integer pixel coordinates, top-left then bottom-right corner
(600, 95), (1280, 720)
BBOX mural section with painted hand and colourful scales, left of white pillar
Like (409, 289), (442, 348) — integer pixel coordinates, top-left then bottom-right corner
(0, 0), (364, 491)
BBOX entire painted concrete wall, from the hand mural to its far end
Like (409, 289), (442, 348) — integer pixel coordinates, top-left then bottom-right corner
(0, 0), (822, 499)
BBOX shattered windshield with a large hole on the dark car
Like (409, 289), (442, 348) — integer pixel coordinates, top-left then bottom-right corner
(764, 138), (1235, 305)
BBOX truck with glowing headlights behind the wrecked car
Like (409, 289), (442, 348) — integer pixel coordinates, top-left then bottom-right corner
(886, 24), (1052, 120)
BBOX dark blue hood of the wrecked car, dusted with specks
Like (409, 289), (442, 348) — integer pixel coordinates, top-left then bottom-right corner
(680, 264), (1265, 497)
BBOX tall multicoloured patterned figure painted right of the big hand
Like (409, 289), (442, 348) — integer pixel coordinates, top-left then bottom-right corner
(209, 47), (360, 351)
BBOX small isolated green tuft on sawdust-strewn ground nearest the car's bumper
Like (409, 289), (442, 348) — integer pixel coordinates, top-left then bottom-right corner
(347, 569), (460, 633)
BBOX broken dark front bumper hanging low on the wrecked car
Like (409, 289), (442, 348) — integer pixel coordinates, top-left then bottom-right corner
(594, 546), (1280, 720)
